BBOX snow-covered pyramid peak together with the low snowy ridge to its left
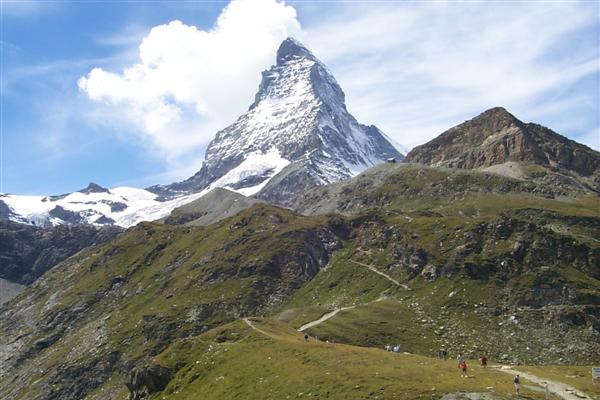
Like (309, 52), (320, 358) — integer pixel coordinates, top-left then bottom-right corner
(0, 38), (403, 227)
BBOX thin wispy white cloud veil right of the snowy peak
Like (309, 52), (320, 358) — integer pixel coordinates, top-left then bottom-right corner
(298, 2), (599, 147)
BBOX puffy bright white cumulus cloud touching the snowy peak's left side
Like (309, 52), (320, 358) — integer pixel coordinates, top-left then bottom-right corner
(78, 0), (302, 161)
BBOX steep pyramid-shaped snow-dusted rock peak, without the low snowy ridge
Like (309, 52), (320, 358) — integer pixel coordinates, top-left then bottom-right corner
(149, 38), (402, 204)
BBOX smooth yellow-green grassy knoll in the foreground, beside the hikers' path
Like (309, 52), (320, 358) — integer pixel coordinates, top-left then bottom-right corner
(152, 320), (542, 400)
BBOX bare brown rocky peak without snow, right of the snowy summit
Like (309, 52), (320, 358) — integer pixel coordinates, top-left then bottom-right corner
(406, 107), (600, 193)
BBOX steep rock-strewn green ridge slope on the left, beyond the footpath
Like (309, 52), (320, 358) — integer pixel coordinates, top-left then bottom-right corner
(0, 205), (345, 400)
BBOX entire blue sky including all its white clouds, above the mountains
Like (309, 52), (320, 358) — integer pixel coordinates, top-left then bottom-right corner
(0, 0), (600, 194)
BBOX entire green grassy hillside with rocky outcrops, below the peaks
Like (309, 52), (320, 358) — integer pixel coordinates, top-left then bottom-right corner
(0, 165), (600, 400)
